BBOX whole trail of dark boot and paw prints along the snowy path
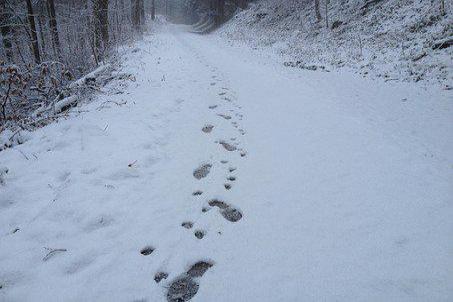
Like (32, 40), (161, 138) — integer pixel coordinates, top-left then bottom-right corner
(140, 65), (247, 302)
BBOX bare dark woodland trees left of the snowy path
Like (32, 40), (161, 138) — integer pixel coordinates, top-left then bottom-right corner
(0, 0), (251, 126)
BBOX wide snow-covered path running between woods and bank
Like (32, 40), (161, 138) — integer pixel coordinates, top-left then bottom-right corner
(0, 27), (453, 301)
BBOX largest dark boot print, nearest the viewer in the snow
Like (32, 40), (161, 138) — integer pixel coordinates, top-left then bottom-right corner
(167, 261), (214, 302)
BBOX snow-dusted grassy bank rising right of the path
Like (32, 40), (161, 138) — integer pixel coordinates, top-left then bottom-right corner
(221, 0), (453, 88)
